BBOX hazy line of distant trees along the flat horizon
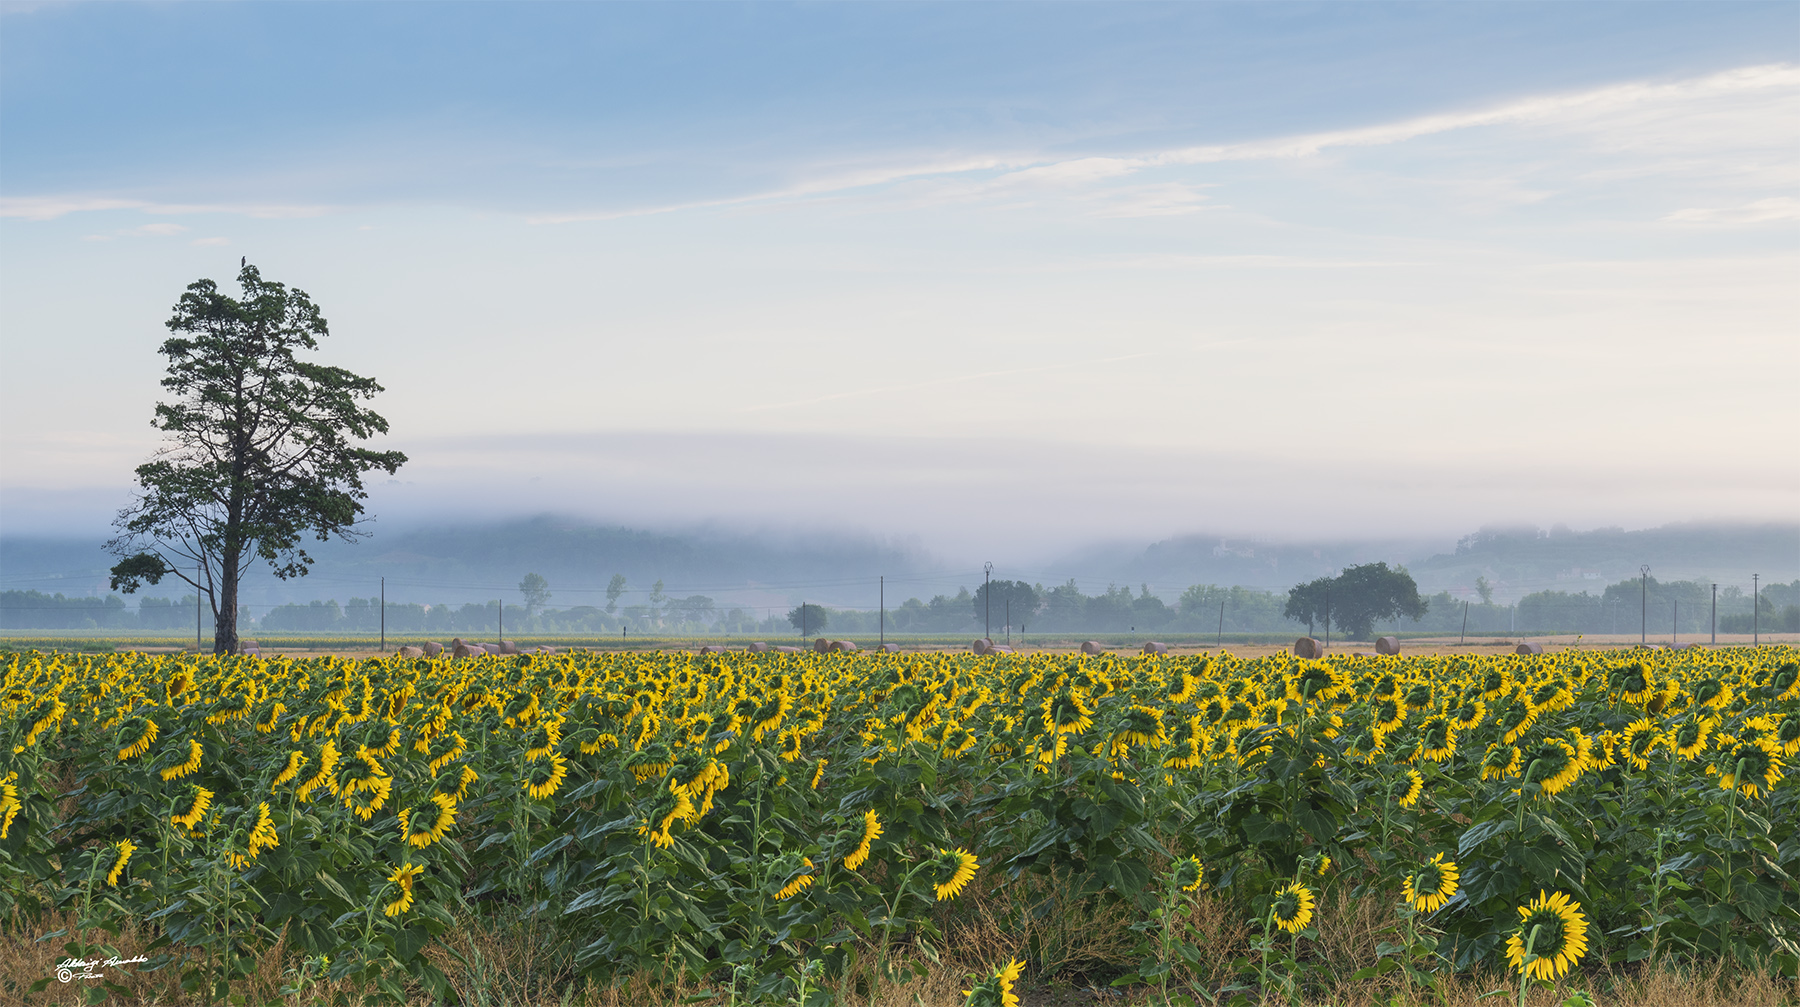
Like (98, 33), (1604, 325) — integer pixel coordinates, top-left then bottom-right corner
(0, 567), (1800, 640)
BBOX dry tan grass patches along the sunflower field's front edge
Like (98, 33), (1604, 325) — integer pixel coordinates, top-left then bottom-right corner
(0, 897), (1800, 1007)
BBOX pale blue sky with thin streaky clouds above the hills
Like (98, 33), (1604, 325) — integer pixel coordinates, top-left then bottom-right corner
(0, 4), (1800, 551)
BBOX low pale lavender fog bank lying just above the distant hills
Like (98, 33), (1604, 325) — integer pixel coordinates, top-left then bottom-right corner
(0, 429), (1800, 562)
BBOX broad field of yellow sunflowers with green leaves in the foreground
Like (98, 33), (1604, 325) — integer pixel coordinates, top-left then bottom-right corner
(0, 647), (1800, 1003)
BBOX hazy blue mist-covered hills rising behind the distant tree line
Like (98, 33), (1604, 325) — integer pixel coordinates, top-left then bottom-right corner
(0, 515), (1800, 620)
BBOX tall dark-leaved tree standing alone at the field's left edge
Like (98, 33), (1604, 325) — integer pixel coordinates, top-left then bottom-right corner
(106, 265), (407, 654)
